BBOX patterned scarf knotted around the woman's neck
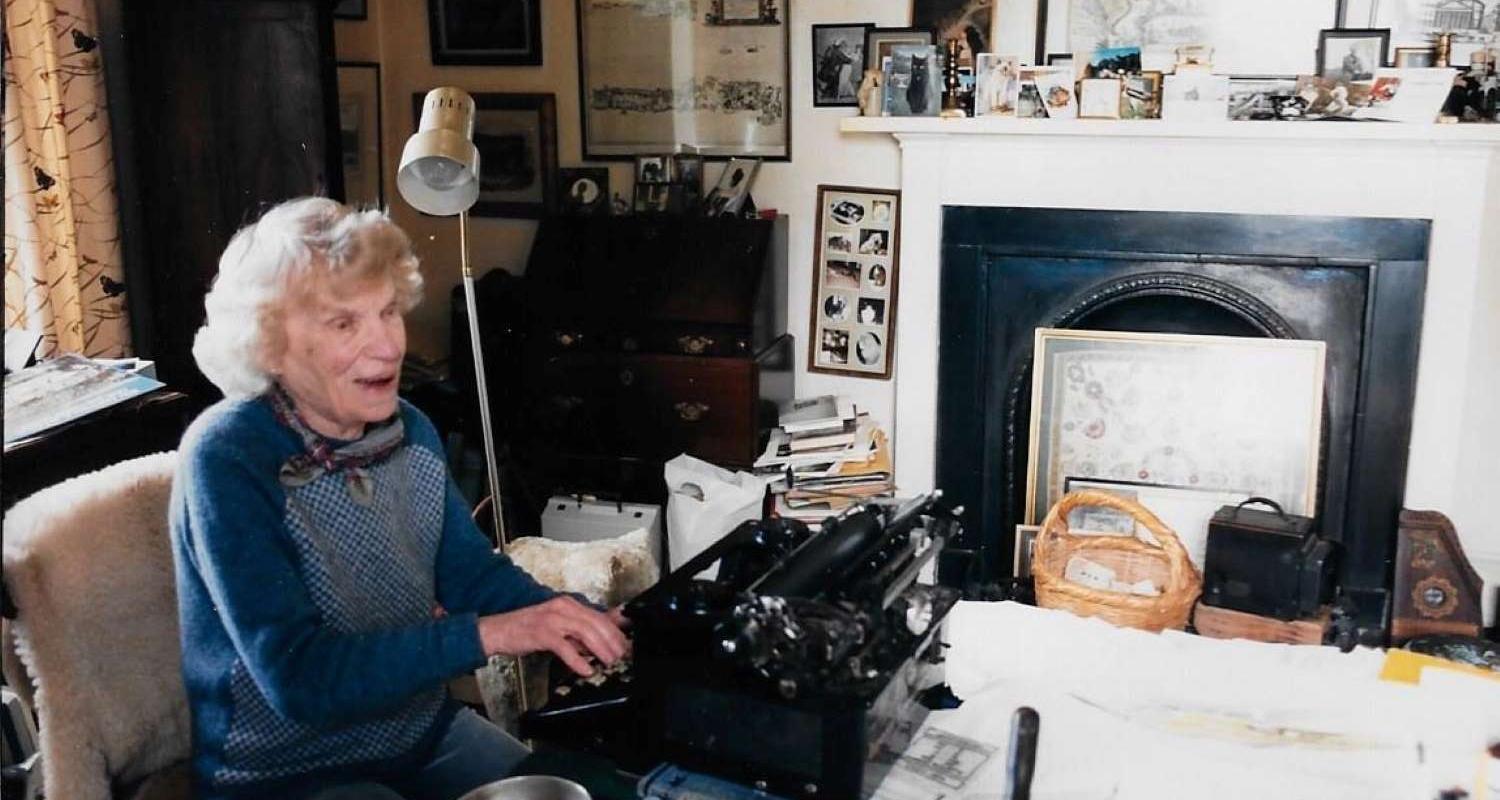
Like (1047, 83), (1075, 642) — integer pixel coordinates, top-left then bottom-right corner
(267, 384), (407, 504)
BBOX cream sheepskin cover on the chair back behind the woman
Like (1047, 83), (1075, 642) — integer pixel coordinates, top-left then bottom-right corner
(5, 453), (192, 800)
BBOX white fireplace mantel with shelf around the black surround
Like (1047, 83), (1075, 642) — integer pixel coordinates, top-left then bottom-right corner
(842, 117), (1500, 560)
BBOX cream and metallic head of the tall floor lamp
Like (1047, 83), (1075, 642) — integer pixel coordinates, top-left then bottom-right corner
(396, 86), (479, 216)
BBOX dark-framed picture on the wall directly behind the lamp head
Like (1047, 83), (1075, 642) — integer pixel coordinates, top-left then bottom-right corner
(411, 92), (558, 218)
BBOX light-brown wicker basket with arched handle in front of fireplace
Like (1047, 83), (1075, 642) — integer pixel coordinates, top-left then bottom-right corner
(1032, 489), (1203, 630)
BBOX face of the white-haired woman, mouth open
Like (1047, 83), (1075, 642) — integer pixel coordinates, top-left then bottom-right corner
(269, 278), (407, 438)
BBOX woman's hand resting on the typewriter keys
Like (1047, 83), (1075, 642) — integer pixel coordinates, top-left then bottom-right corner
(479, 594), (630, 675)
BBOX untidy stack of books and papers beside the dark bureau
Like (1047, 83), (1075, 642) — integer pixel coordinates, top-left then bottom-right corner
(755, 395), (896, 525)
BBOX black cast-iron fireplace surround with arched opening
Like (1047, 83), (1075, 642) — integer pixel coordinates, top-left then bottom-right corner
(936, 206), (1430, 642)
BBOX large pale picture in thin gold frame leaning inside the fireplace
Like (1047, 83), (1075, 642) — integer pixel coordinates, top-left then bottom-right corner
(1026, 327), (1326, 524)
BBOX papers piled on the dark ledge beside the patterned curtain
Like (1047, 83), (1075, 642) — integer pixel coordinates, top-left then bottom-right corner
(5, 353), (164, 446)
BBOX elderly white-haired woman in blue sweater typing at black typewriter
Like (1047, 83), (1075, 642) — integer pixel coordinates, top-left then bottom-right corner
(171, 198), (626, 798)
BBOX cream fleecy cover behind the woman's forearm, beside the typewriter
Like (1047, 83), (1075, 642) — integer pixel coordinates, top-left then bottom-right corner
(476, 528), (662, 734)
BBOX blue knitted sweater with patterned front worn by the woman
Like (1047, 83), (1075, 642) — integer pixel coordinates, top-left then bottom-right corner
(171, 398), (554, 798)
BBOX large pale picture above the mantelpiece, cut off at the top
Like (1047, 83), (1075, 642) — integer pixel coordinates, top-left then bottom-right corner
(1035, 0), (1344, 75)
